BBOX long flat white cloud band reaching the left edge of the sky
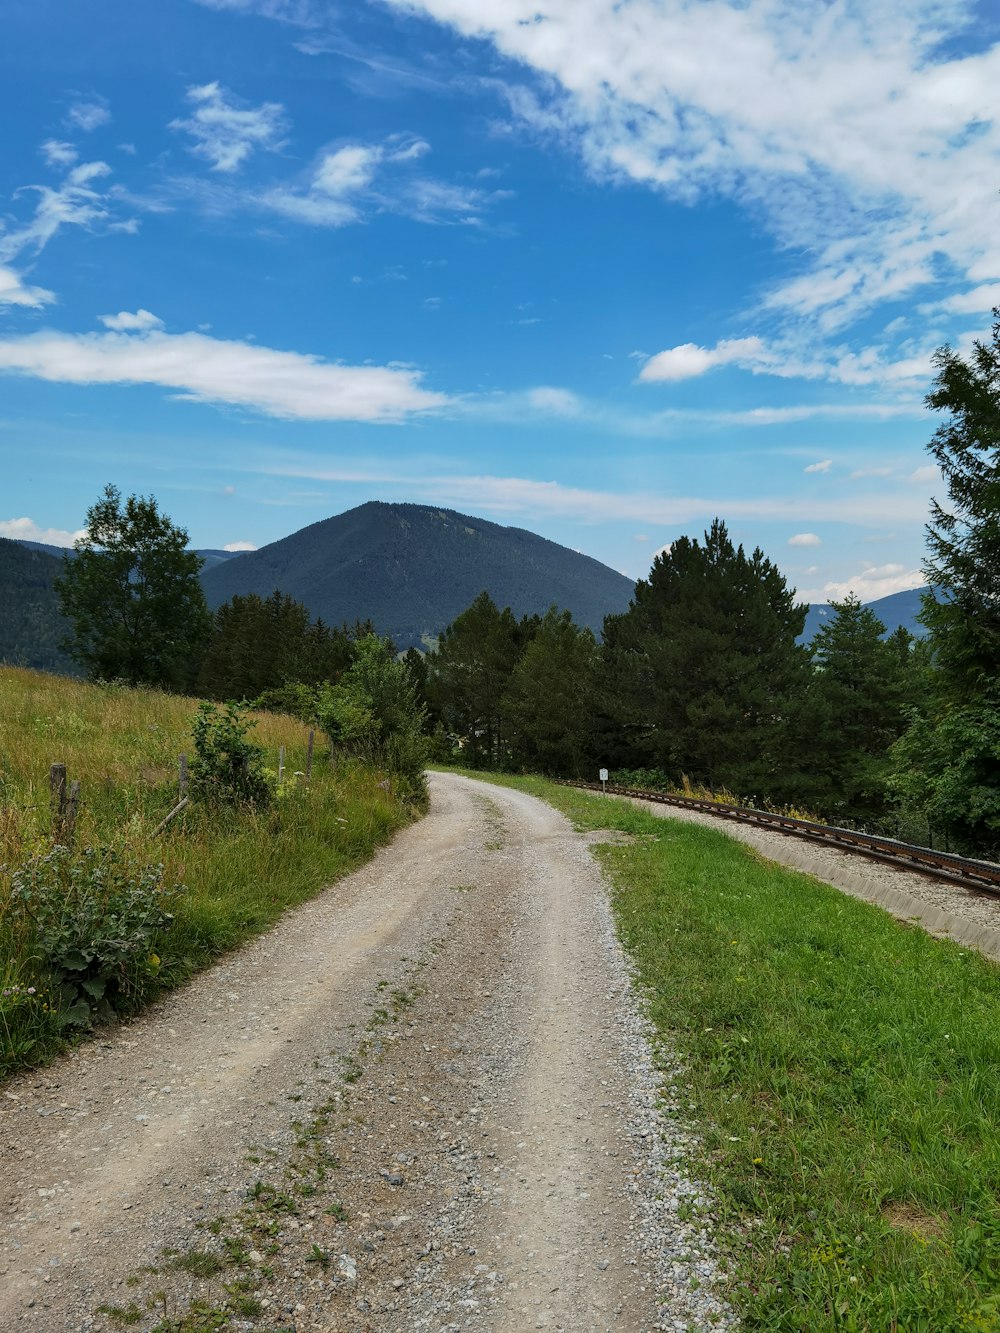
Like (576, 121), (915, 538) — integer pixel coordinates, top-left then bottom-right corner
(0, 319), (448, 421)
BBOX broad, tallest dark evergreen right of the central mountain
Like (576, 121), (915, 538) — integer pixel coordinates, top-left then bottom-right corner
(605, 519), (807, 796)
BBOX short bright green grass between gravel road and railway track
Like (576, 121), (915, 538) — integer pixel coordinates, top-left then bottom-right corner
(450, 774), (1000, 1333)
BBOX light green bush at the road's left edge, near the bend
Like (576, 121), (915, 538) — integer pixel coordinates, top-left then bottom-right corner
(316, 635), (427, 794)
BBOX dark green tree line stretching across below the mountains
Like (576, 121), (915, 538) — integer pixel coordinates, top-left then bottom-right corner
(51, 311), (1000, 849)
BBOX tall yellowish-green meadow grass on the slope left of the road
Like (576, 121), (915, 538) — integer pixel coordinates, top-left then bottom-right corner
(0, 667), (413, 1076)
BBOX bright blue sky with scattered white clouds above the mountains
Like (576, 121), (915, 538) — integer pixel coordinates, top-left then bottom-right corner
(0, 0), (1000, 600)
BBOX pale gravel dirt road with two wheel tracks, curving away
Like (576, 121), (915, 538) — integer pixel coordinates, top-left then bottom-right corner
(0, 774), (728, 1333)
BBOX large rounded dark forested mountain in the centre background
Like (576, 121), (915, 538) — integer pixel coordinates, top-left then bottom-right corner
(201, 501), (635, 648)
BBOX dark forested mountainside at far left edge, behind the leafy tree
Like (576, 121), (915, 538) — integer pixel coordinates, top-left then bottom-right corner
(0, 537), (77, 674)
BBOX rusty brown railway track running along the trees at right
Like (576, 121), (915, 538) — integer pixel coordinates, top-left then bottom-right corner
(561, 781), (1000, 897)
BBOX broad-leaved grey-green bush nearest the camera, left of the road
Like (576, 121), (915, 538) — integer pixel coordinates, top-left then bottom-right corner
(11, 846), (184, 1026)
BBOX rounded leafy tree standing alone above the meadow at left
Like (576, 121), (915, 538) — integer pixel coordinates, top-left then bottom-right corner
(56, 485), (209, 690)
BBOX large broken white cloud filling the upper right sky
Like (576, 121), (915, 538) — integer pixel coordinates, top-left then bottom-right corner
(388, 0), (1000, 327)
